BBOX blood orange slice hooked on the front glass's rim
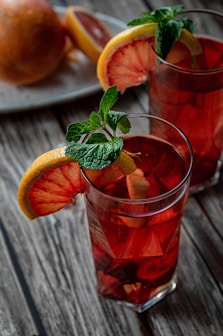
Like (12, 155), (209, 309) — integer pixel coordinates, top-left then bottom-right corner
(18, 147), (136, 219)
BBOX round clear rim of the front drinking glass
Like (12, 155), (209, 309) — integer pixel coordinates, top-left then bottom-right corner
(80, 113), (194, 204)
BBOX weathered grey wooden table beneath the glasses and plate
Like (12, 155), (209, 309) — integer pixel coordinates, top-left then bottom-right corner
(0, 0), (223, 336)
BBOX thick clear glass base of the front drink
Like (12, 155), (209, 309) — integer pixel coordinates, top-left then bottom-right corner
(116, 274), (177, 313)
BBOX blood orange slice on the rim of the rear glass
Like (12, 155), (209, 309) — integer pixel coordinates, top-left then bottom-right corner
(97, 23), (202, 91)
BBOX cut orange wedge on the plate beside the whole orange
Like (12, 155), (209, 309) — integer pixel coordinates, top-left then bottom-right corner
(65, 6), (112, 63)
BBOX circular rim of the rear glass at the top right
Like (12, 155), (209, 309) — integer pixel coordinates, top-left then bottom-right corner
(155, 8), (223, 75)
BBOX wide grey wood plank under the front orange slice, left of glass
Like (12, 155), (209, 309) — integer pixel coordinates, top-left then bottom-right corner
(0, 100), (150, 336)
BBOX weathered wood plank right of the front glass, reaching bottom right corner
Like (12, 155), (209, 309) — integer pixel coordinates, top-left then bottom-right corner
(146, 198), (223, 336)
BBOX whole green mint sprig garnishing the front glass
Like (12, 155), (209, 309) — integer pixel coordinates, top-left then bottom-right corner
(65, 86), (130, 169)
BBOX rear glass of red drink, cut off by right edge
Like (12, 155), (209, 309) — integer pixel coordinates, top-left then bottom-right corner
(149, 9), (223, 193)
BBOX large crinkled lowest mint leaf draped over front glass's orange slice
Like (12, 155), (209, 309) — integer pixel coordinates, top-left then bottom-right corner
(65, 137), (123, 169)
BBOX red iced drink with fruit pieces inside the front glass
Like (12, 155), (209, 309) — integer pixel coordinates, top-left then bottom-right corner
(86, 136), (187, 304)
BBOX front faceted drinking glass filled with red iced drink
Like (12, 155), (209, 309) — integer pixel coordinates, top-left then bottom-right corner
(83, 114), (193, 312)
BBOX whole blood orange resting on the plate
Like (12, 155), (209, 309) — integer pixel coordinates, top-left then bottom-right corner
(0, 0), (66, 85)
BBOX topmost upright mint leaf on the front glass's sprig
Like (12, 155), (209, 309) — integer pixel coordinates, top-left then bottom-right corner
(99, 86), (118, 122)
